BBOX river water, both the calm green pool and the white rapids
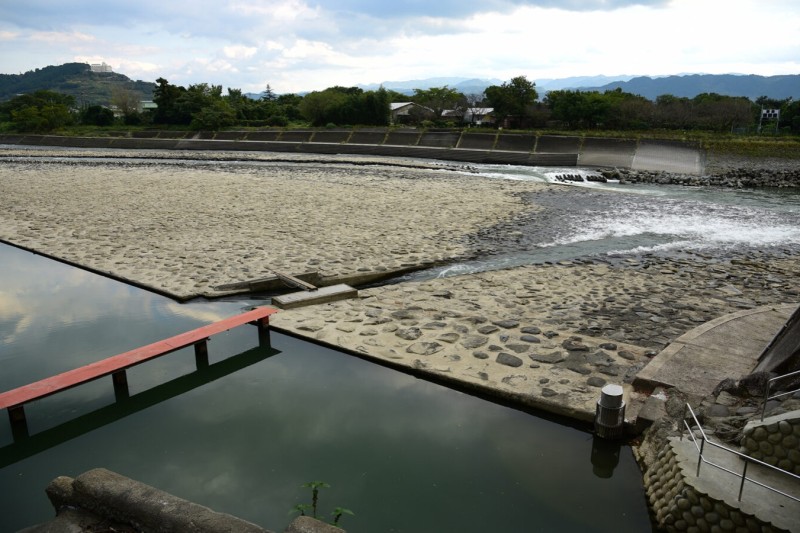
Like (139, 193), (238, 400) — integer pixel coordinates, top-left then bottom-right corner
(0, 151), (800, 532)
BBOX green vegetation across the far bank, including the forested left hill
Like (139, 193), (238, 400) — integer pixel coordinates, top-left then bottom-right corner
(0, 63), (800, 157)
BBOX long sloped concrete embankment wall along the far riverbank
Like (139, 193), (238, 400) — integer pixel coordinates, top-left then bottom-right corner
(0, 128), (704, 174)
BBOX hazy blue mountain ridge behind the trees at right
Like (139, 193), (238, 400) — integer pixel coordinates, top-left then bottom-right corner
(581, 74), (800, 101)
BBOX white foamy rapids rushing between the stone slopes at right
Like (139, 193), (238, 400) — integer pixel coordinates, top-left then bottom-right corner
(478, 165), (800, 254)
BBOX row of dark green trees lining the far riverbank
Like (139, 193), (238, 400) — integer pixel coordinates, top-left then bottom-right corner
(0, 76), (800, 134)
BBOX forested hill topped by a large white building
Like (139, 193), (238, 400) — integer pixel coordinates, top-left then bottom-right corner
(0, 63), (155, 106)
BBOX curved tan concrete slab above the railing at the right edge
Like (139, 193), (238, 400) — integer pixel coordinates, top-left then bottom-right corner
(634, 304), (797, 398)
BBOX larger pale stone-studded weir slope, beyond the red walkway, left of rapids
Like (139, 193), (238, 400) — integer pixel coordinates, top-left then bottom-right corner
(0, 152), (543, 299)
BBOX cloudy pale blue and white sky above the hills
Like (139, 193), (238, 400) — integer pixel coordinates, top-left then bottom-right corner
(0, 0), (800, 93)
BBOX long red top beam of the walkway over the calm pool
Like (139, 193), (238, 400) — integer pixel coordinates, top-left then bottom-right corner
(0, 307), (278, 409)
